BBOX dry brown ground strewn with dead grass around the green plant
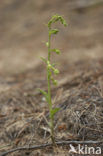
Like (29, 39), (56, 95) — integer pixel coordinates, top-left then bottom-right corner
(0, 0), (103, 156)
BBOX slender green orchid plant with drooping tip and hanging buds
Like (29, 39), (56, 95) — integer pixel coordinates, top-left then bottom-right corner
(39, 15), (67, 144)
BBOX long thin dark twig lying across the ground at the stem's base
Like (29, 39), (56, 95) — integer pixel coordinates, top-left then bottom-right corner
(0, 140), (103, 156)
